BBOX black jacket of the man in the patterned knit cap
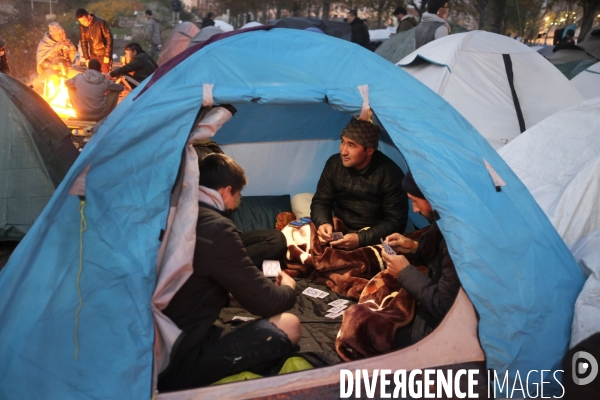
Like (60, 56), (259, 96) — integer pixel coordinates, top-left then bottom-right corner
(310, 151), (408, 247)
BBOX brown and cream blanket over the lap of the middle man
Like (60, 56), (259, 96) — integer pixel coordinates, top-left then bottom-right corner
(281, 218), (385, 299)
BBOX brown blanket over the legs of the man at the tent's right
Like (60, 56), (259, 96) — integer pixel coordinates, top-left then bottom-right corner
(335, 271), (416, 361)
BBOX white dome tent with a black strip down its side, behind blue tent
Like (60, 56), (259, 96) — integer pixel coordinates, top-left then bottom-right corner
(398, 31), (583, 149)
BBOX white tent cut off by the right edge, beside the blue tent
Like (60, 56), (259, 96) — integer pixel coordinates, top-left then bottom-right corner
(499, 97), (600, 347)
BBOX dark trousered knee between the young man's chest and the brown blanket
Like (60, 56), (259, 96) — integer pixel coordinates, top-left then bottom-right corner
(240, 229), (287, 271)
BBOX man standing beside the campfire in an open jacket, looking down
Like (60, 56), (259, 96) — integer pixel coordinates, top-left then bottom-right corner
(75, 8), (113, 74)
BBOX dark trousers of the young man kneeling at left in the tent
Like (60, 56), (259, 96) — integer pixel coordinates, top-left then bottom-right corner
(158, 319), (294, 392)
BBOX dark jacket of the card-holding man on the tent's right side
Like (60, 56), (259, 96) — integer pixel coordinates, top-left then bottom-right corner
(398, 222), (460, 345)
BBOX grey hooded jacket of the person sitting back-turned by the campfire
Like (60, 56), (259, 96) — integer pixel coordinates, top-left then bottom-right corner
(65, 69), (123, 118)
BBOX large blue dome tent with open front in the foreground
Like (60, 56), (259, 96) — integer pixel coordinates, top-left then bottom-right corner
(0, 27), (584, 399)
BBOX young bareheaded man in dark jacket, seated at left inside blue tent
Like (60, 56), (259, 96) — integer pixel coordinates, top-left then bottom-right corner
(158, 154), (302, 391)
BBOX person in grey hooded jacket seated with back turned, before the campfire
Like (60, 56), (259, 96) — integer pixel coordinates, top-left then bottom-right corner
(65, 60), (124, 121)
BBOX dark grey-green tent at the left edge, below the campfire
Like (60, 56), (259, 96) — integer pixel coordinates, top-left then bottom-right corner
(0, 74), (79, 241)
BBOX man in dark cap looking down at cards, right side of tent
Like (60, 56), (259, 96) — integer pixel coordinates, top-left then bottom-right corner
(381, 171), (460, 349)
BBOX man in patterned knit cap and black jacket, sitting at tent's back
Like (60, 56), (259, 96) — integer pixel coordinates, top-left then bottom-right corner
(310, 118), (408, 250)
